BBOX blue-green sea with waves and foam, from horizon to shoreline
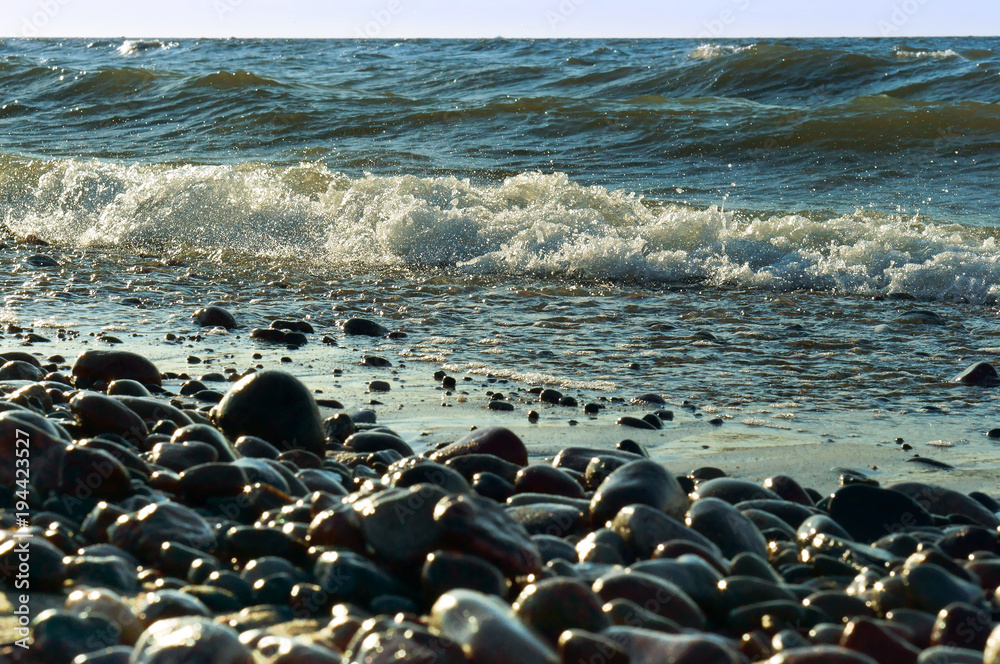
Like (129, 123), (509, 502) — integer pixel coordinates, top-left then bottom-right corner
(0, 38), (1000, 461)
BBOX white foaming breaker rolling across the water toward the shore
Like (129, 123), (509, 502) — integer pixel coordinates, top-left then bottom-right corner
(0, 158), (1000, 303)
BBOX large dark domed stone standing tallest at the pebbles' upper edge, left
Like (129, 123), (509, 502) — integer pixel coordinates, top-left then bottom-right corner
(212, 371), (326, 457)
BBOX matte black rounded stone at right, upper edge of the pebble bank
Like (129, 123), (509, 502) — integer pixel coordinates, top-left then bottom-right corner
(828, 484), (933, 542)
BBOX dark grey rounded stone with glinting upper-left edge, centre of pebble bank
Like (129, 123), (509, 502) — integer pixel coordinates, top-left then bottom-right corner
(354, 484), (448, 565)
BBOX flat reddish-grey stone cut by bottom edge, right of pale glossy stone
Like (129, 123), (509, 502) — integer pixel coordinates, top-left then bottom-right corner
(603, 626), (745, 664)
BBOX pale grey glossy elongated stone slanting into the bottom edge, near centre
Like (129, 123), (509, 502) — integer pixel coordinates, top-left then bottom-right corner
(430, 590), (560, 664)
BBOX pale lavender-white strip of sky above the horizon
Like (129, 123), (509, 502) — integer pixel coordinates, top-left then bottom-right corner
(0, 0), (1000, 39)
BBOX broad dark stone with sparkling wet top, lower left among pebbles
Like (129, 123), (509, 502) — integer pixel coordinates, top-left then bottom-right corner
(108, 501), (216, 561)
